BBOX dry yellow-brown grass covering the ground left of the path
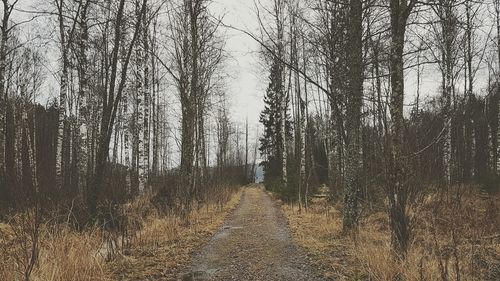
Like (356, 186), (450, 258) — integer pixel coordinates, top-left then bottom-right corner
(0, 187), (241, 281)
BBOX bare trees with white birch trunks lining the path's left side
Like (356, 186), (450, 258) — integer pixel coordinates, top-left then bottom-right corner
(0, 0), (255, 220)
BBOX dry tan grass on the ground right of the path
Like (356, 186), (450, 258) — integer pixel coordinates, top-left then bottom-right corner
(283, 189), (500, 281)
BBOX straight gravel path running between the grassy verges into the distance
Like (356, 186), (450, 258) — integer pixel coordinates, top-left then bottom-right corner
(180, 187), (319, 281)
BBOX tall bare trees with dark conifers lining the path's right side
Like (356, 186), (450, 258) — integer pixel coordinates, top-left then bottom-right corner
(256, 0), (500, 259)
